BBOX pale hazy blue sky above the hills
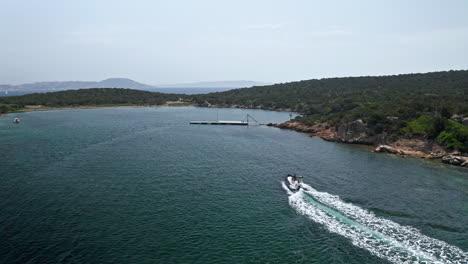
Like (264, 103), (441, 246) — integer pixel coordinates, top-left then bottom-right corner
(0, 0), (468, 84)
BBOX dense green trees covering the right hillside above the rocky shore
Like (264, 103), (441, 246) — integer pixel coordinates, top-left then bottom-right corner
(193, 70), (468, 151)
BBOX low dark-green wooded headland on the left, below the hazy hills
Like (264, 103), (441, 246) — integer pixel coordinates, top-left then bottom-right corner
(0, 88), (186, 107)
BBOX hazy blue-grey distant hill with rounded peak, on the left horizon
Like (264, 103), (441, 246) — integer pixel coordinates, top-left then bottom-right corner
(0, 78), (156, 92)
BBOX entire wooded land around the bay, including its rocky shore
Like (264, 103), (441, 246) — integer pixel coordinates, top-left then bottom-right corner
(0, 70), (468, 167)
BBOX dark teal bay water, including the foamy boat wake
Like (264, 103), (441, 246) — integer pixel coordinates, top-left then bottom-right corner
(0, 107), (468, 263)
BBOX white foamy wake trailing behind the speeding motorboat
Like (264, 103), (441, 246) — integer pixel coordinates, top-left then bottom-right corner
(283, 182), (468, 264)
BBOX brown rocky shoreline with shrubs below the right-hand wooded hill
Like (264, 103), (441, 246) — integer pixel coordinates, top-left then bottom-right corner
(267, 120), (468, 168)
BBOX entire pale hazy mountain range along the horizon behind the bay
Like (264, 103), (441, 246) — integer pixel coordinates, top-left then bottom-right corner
(0, 78), (267, 92)
